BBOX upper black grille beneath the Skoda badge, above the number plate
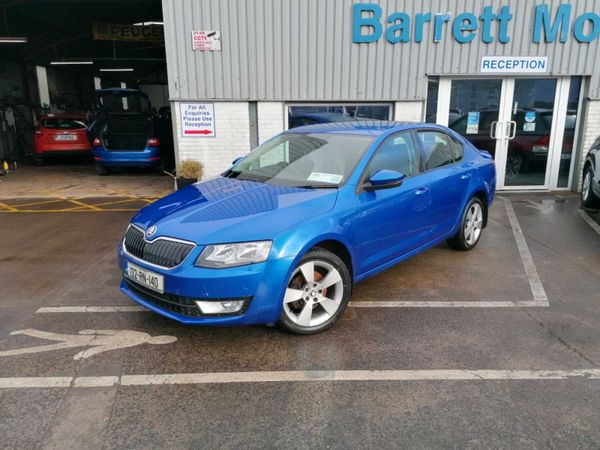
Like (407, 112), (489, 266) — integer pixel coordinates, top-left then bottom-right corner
(125, 226), (194, 269)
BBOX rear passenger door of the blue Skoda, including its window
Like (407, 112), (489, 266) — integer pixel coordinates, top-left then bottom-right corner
(416, 130), (472, 240)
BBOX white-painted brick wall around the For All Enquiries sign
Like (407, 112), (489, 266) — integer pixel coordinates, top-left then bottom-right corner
(172, 102), (250, 178)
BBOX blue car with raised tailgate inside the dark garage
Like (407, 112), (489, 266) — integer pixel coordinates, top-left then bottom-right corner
(88, 88), (174, 175)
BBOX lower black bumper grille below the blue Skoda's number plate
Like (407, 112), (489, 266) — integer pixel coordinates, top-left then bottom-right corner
(125, 278), (252, 317)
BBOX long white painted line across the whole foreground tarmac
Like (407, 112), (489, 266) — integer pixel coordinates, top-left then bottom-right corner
(0, 369), (600, 389)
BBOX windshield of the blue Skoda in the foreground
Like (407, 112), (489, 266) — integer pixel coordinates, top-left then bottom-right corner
(224, 133), (373, 188)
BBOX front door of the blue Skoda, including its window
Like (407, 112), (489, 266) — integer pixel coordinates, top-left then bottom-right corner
(357, 132), (430, 274)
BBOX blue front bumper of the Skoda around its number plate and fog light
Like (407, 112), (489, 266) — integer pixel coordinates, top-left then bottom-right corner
(119, 246), (293, 325)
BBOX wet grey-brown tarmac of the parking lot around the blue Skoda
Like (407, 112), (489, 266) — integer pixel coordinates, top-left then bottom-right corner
(0, 194), (600, 449)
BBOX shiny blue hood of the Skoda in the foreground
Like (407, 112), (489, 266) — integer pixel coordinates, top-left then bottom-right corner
(132, 177), (337, 244)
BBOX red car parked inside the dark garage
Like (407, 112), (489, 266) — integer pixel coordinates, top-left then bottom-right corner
(34, 113), (92, 164)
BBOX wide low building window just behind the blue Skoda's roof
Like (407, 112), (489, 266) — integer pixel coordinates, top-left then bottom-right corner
(287, 103), (393, 129)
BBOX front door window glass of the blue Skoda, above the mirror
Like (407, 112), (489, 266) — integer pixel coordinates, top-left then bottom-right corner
(367, 133), (419, 179)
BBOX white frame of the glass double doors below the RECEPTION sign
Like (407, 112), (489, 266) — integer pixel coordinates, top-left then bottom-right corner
(436, 74), (583, 191)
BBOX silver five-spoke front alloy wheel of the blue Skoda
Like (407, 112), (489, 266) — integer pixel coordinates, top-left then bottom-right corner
(283, 260), (344, 328)
